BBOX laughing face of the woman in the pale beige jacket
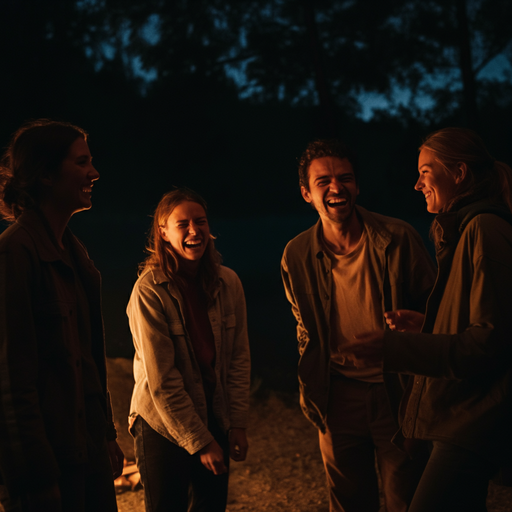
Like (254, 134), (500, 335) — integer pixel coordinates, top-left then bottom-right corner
(160, 201), (210, 269)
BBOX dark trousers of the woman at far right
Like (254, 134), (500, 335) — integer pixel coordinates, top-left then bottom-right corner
(409, 441), (498, 512)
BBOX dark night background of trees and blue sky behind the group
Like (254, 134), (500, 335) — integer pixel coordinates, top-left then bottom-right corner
(0, 0), (512, 390)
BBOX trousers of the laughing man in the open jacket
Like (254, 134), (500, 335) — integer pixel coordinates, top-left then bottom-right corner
(320, 376), (428, 512)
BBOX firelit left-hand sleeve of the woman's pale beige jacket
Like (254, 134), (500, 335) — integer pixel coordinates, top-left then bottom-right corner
(127, 283), (213, 454)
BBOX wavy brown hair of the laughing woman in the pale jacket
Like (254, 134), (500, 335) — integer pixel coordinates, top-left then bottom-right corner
(139, 187), (222, 302)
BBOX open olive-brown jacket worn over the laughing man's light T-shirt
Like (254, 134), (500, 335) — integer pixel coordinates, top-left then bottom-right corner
(281, 206), (435, 432)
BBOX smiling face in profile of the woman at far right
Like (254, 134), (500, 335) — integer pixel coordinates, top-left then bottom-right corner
(414, 148), (463, 213)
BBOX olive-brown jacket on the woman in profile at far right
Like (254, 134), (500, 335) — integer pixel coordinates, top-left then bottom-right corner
(384, 201), (512, 457)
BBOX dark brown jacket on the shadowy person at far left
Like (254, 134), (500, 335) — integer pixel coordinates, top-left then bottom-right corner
(0, 211), (116, 491)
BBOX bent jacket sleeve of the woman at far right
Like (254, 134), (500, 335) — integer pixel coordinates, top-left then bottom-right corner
(384, 219), (512, 379)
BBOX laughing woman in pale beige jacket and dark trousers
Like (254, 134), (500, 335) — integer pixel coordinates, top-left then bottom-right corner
(127, 189), (250, 512)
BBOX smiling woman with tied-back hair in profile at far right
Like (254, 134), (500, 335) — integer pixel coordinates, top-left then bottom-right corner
(346, 128), (512, 512)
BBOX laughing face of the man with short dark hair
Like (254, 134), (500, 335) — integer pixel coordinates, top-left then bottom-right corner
(301, 156), (359, 224)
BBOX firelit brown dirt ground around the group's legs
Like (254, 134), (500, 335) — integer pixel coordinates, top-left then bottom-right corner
(108, 358), (512, 512)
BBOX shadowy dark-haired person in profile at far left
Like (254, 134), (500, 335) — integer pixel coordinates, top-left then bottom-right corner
(0, 119), (123, 512)
